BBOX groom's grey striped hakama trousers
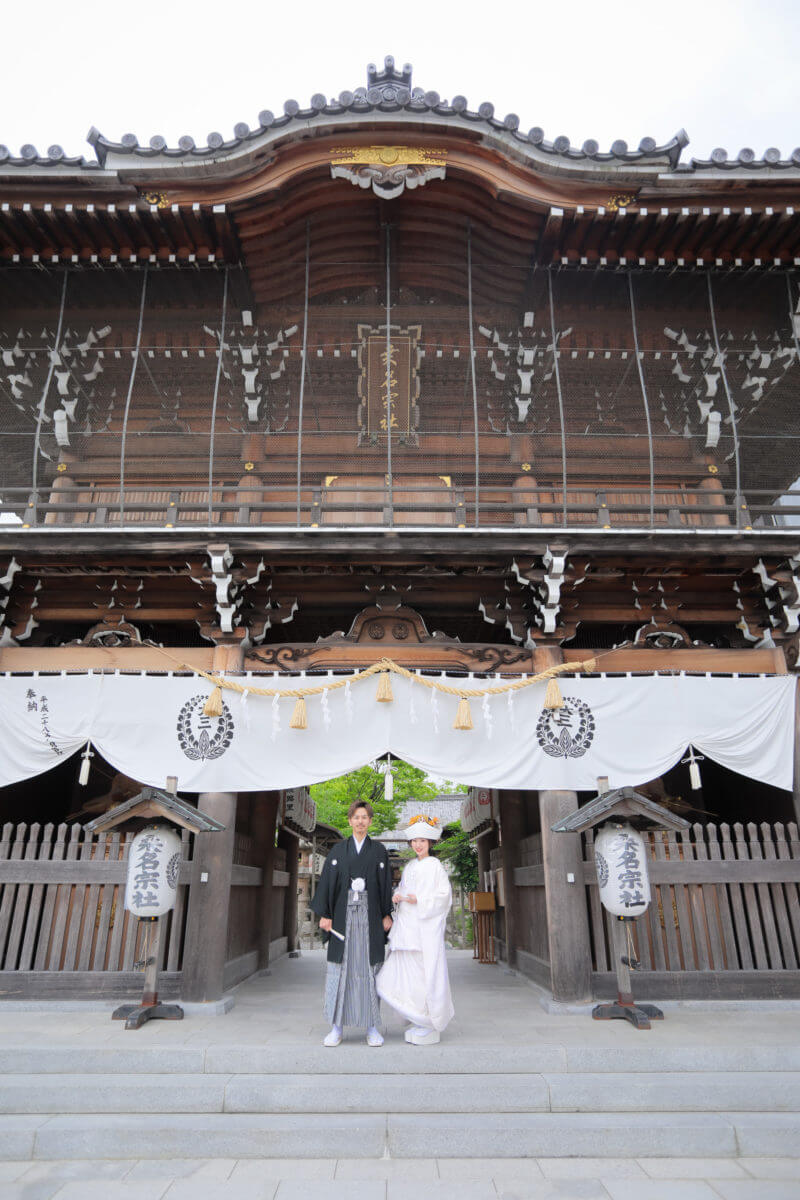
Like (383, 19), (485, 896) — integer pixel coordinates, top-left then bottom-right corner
(325, 889), (383, 1030)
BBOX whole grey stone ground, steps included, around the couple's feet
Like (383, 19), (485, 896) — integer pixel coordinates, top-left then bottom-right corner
(0, 952), (800, 1200)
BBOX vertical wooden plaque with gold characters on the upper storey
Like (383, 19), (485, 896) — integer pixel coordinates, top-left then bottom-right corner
(359, 325), (422, 445)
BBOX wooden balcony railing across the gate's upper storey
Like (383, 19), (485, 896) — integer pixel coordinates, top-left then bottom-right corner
(6, 476), (800, 533)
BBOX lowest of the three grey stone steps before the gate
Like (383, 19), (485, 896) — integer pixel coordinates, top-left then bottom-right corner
(0, 1111), (800, 1160)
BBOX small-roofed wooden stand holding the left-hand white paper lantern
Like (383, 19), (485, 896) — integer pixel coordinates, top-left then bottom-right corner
(85, 775), (224, 1030)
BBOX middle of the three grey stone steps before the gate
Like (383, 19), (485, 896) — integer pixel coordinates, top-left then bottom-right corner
(0, 1072), (800, 1115)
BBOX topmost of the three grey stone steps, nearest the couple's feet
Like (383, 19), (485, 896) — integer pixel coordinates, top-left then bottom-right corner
(0, 1028), (800, 1076)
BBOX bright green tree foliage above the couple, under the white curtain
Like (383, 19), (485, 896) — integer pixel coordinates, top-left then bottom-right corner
(311, 758), (441, 834)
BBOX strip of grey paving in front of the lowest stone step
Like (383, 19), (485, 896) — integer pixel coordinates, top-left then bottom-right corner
(0, 1158), (800, 1200)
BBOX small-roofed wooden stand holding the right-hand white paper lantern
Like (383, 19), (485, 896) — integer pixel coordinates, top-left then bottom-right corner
(552, 779), (688, 1030)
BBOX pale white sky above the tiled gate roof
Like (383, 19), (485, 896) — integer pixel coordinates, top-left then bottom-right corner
(0, 0), (800, 161)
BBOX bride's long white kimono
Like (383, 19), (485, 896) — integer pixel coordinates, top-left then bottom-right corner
(375, 857), (453, 1032)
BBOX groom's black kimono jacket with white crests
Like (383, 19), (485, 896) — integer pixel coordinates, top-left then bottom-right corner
(311, 838), (392, 966)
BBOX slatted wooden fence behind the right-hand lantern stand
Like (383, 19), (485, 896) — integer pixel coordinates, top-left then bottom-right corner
(584, 822), (800, 998)
